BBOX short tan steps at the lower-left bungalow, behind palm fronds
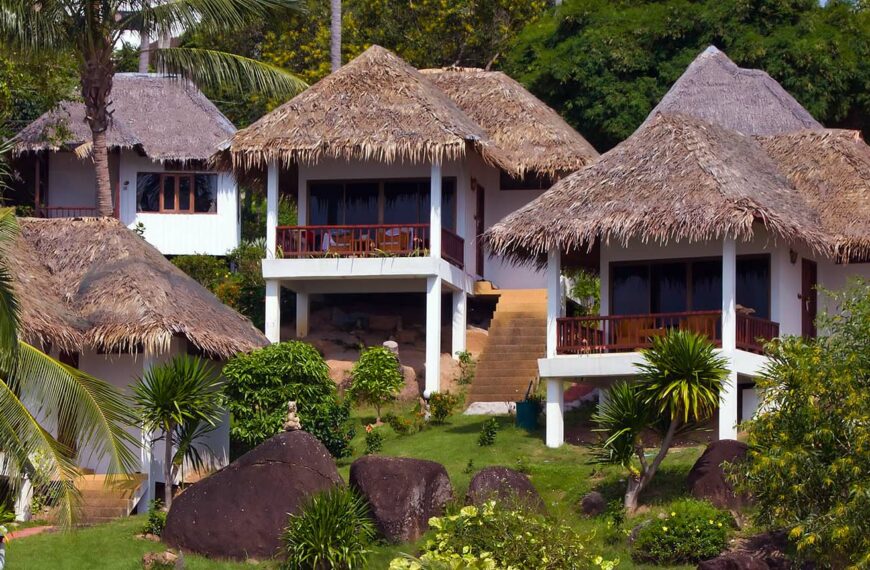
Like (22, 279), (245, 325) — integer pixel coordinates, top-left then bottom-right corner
(76, 473), (147, 524)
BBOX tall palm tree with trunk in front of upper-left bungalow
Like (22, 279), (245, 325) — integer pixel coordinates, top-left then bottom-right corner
(0, 0), (305, 216)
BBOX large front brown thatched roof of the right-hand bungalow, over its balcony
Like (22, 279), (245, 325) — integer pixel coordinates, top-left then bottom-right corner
(486, 114), (830, 262)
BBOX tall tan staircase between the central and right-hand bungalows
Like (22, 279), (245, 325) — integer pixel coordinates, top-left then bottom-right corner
(469, 289), (547, 403)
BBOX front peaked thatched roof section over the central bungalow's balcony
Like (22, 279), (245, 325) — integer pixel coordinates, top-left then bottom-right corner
(230, 46), (520, 174)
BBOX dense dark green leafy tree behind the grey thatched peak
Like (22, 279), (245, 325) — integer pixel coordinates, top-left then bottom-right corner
(503, 0), (870, 151)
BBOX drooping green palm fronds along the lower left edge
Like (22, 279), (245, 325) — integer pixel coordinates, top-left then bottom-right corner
(0, 204), (138, 525)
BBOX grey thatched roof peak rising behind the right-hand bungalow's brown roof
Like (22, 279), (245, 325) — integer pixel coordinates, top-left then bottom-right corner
(647, 46), (822, 135)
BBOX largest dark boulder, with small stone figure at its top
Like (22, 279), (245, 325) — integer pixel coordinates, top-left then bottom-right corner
(163, 431), (342, 559)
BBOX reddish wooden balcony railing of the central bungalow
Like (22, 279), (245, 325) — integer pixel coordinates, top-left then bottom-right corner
(276, 224), (465, 268)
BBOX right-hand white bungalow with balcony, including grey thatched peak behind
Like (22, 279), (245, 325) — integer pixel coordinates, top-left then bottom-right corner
(487, 47), (870, 447)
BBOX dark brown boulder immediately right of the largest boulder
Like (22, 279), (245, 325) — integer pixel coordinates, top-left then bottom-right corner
(350, 455), (453, 543)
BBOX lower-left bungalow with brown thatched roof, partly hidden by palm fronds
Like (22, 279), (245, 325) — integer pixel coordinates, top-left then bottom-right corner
(9, 218), (267, 522)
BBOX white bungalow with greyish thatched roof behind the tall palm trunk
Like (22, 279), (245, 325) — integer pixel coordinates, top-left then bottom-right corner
(16, 73), (241, 255)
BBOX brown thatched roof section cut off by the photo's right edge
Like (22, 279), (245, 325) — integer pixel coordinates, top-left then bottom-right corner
(758, 130), (870, 259)
